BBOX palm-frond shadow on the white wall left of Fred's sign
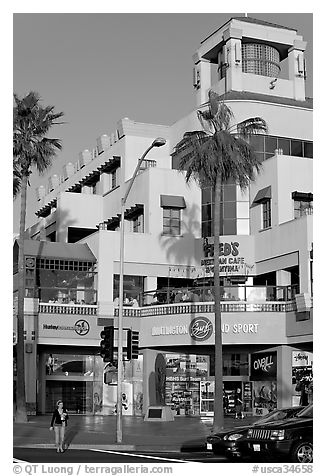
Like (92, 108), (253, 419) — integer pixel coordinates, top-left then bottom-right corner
(159, 204), (201, 272)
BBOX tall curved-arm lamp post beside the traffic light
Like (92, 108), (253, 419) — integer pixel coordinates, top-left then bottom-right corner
(117, 137), (166, 443)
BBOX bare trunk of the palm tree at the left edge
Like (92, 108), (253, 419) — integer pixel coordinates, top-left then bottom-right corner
(15, 175), (28, 423)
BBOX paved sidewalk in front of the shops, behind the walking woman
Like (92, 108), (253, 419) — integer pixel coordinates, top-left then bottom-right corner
(13, 415), (257, 452)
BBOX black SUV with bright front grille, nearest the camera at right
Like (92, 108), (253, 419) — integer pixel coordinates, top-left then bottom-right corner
(238, 404), (313, 463)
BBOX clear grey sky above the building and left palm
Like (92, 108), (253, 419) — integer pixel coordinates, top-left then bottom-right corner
(13, 13), (313, 232)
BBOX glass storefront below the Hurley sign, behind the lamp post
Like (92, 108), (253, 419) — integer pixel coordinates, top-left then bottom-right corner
(40, 352), (143, 415)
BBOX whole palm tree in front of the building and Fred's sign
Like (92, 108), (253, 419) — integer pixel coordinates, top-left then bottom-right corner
(174, 91), (267, 431)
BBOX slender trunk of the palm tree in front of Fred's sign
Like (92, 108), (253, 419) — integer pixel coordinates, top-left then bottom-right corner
(213, 179), (224, 431)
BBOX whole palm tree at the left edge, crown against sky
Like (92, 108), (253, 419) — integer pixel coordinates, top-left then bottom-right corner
(13, 91), (63, 423)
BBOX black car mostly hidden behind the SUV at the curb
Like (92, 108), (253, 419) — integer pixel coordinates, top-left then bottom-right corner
(206, 406), (304, 459)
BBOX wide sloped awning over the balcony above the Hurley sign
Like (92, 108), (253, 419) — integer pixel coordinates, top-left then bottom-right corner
(17, 240), (96, 263)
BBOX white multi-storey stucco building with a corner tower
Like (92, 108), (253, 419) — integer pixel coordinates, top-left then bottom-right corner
(14, 17), (313, 415)
